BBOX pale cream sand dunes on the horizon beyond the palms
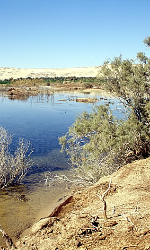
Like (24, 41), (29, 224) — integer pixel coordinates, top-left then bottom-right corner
(0, 67), (100, 80)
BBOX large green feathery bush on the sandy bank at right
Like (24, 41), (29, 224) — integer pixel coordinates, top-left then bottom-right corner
(59, 38), (150, 182)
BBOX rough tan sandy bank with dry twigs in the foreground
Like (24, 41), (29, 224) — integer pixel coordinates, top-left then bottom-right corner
(3, 158), (146, 250)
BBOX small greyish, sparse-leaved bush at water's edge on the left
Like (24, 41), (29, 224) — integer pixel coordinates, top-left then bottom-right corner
(0, 126), (33, 189)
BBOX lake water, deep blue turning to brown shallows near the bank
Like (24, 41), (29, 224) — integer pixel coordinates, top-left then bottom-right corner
(0, 92), (123, 244)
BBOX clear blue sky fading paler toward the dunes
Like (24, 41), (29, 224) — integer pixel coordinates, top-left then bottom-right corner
(0, 0), (150, 69)
